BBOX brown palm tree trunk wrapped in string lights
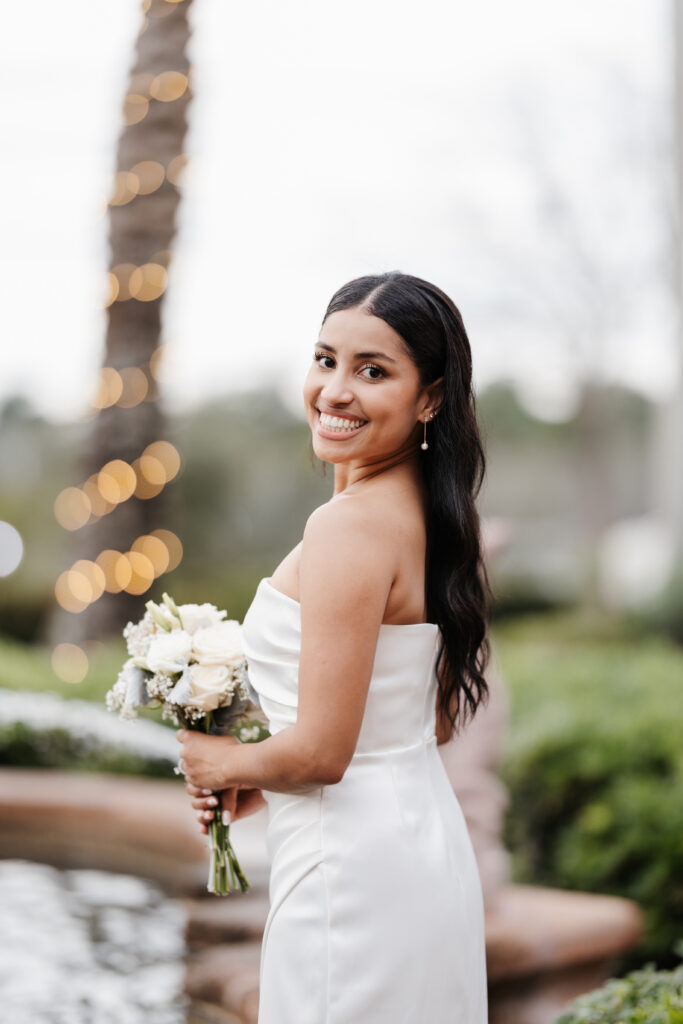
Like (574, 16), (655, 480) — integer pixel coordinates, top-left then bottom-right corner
(49, 0), (193, 642)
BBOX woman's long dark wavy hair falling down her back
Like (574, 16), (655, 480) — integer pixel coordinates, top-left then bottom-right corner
(323, 270), (493, 730)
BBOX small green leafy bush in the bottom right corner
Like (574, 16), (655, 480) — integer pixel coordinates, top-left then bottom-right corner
(555, 964), (683, 1024)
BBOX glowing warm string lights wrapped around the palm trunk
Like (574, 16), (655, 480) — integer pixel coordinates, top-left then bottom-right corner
(53, 6), (193, 622)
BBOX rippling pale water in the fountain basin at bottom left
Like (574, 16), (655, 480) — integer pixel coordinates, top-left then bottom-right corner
(0, 860), (188, 1024)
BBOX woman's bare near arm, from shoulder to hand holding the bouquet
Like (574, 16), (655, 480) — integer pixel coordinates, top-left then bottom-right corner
(178, 498), (396, 793)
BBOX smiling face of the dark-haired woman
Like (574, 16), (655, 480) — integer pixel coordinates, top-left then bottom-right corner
(303, 307), (428, 463)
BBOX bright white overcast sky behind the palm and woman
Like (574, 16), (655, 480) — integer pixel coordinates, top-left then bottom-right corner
(0, 0), (677, 419)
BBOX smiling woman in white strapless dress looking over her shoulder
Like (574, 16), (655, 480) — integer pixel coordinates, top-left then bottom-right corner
(178, 271), (489, 1024)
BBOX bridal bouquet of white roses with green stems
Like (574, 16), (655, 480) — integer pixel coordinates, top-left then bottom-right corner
(105, 594), (268, 896)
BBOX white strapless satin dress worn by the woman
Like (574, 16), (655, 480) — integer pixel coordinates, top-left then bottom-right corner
(243, 577), (487, 1024)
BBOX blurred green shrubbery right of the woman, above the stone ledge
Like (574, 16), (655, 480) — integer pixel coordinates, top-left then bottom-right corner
(494, 613), (683, 972)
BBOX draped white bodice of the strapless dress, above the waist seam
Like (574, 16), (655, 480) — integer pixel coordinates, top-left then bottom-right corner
(243, 577), (440, 756)
